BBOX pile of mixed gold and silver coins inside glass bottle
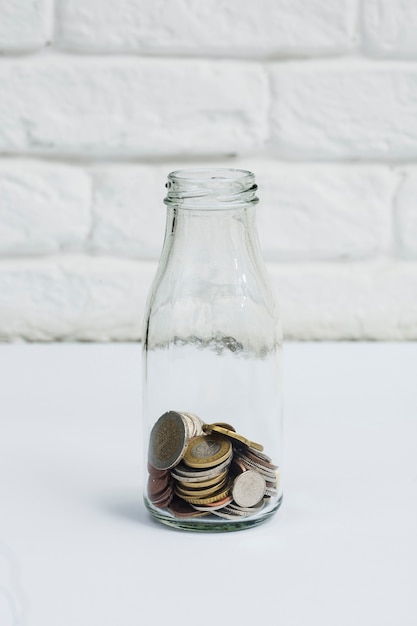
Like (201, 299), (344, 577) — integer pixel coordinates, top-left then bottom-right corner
(148, 411), (279, 519)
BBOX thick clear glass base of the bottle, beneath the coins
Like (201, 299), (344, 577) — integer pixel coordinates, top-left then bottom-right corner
(144, 495), (283, 533)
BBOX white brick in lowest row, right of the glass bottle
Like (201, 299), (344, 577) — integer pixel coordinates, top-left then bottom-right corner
(269, 260), (417, 341)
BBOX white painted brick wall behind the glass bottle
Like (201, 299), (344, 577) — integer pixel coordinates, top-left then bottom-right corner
(0, 0), (417, 341)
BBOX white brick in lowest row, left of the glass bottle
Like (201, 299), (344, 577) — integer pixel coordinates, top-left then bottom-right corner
(0, 255), (155, 341)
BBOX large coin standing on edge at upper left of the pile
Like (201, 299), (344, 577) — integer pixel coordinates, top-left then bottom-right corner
(148, 411), (188, 470)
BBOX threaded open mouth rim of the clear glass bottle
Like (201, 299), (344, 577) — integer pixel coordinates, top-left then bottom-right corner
(164, 168), (259, 210)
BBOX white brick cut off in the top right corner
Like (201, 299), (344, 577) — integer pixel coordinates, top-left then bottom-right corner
(363, 0), (417, 57)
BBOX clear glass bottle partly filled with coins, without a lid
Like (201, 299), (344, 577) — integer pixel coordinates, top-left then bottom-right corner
(142, 168), (282, 531)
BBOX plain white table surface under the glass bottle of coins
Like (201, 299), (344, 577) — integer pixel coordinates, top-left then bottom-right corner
(0, 343), (417, 626)
